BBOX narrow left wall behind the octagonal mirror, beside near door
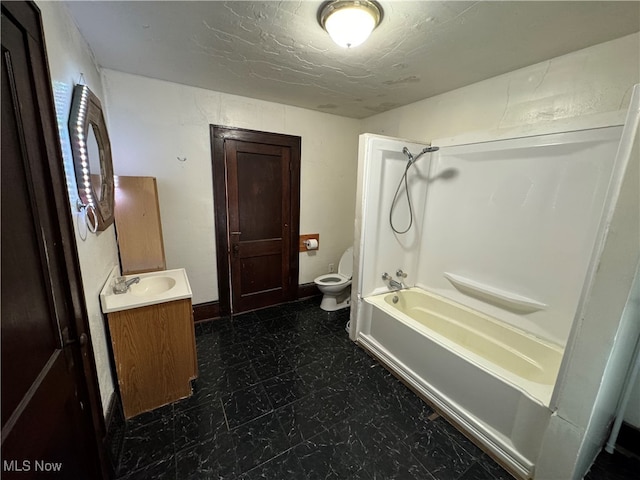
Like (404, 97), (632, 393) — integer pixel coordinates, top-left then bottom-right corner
(38, 2), (118, 413)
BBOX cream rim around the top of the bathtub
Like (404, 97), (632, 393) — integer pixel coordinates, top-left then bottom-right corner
(356, 287), (564, 408)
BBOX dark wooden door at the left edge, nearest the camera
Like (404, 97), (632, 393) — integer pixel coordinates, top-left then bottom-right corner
(0, 3), (102, 479)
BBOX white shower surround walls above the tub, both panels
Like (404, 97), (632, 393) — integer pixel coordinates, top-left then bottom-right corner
(358, 126), (622, 346)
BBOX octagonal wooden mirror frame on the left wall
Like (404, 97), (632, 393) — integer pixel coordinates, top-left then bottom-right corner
(69, 85), (114, 231)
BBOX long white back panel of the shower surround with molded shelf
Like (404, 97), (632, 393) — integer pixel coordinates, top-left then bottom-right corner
(416, 127), (622, 346)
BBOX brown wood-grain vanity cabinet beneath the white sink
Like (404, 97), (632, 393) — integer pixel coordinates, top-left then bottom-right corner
(107, 299), (198, 419)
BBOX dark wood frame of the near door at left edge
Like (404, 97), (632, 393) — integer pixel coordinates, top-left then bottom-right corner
(2, 2), (109, 479)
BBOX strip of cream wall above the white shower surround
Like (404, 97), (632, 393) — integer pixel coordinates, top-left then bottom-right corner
(362, 33), (640, 142)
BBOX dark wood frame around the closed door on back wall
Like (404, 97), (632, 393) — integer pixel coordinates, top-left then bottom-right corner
(210, 125), (302, 315)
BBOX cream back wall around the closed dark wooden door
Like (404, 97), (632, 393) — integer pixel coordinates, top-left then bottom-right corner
(103, 70), (360, 304)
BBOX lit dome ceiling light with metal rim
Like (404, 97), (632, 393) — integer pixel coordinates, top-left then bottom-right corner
(318, 0), (382, 48)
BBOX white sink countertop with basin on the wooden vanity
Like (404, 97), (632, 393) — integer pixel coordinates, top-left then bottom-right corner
(100, 266), (193, 313)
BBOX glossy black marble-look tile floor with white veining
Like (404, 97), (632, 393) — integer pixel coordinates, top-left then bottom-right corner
(117, 298), (637, 480)
